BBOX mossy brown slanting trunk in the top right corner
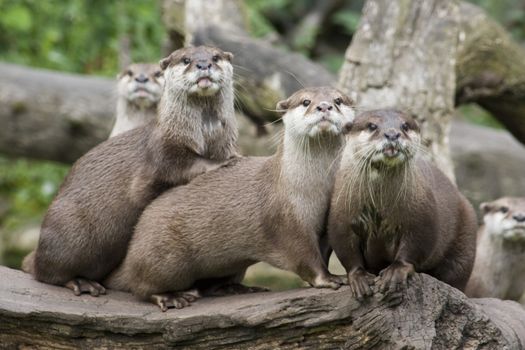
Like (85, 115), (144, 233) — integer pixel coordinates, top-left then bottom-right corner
(456, 3), (525, 144)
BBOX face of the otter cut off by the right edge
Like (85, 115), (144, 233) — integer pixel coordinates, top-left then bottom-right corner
(480, 197), (525, 243)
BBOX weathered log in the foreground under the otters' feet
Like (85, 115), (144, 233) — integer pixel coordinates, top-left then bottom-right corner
(0, 267), (525, 349)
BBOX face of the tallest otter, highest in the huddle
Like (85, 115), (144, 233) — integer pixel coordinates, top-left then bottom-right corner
(160, 46), (233, 97)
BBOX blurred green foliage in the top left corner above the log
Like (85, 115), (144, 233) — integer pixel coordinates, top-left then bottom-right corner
(0, 0), (164, 75)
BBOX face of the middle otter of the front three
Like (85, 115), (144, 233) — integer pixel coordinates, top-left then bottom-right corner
(277, 87), (355, 137)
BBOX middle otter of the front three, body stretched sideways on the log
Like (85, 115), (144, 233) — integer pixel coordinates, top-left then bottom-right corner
(105, 87), (354, 311)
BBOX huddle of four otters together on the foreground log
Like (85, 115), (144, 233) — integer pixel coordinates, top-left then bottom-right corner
(23, 46), (524, 311)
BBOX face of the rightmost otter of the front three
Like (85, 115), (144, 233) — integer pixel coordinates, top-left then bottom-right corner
(347, 109), (421, 167)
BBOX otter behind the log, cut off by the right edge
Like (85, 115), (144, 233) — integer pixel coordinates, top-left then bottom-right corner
(465, 197), (525, 303)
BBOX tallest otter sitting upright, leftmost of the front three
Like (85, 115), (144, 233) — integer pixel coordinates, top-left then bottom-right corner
(23, 46), (237, 296)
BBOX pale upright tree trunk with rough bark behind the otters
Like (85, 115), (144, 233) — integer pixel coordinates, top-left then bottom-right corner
(339, 0), (459, 179)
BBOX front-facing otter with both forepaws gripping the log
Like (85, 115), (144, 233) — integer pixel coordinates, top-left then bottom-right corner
(327, 109), (477, 299)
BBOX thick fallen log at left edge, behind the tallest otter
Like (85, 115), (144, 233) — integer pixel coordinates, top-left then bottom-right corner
(0, 63), (116, 163)
